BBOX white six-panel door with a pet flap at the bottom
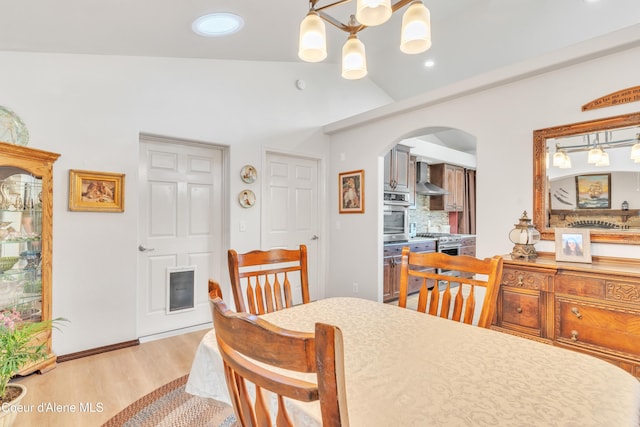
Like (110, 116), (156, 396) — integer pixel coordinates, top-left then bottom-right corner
(138, 136), (223, 337)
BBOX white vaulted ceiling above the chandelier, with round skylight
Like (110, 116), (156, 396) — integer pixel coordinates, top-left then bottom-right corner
(0, 0), (640, 100)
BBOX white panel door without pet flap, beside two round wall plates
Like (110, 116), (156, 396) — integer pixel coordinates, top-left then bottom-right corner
(263, 153), (322, 303)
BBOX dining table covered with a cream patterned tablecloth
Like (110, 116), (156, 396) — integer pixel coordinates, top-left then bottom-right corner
(186, 297), (640, 427)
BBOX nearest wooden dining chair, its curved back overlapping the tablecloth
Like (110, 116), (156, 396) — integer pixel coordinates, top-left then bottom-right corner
(211, 298), (349, 427)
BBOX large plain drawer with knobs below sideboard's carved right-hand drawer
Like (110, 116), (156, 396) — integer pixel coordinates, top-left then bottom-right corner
(556, 296), (640, 357)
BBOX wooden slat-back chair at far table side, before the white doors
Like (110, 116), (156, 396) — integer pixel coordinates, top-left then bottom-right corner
(228, 245), (310, 314)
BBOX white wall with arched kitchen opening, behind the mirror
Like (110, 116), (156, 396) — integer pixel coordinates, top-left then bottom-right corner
(325, 25), (640, 300)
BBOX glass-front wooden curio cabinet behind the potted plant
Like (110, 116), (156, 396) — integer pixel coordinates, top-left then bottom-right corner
(0, 142), (60, 375)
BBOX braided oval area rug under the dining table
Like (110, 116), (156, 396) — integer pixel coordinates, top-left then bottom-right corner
(102, 375), (236, 427)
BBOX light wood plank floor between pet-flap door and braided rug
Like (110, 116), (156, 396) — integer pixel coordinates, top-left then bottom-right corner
(14, 330), (207, 427)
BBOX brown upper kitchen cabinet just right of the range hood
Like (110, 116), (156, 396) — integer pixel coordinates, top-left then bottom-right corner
(429, 163), (465, 212)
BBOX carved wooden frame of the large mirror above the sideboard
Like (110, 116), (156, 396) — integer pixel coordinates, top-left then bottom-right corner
(533, 112), (640, 245)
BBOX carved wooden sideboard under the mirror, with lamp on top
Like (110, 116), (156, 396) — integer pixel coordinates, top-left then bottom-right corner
(492, 253), (640, 378)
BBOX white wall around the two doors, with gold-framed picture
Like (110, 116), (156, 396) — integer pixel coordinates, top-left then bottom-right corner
(0, 52), (390, 354)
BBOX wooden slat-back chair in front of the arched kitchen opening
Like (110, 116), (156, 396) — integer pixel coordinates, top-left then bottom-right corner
(398, 247), (502, 328)
